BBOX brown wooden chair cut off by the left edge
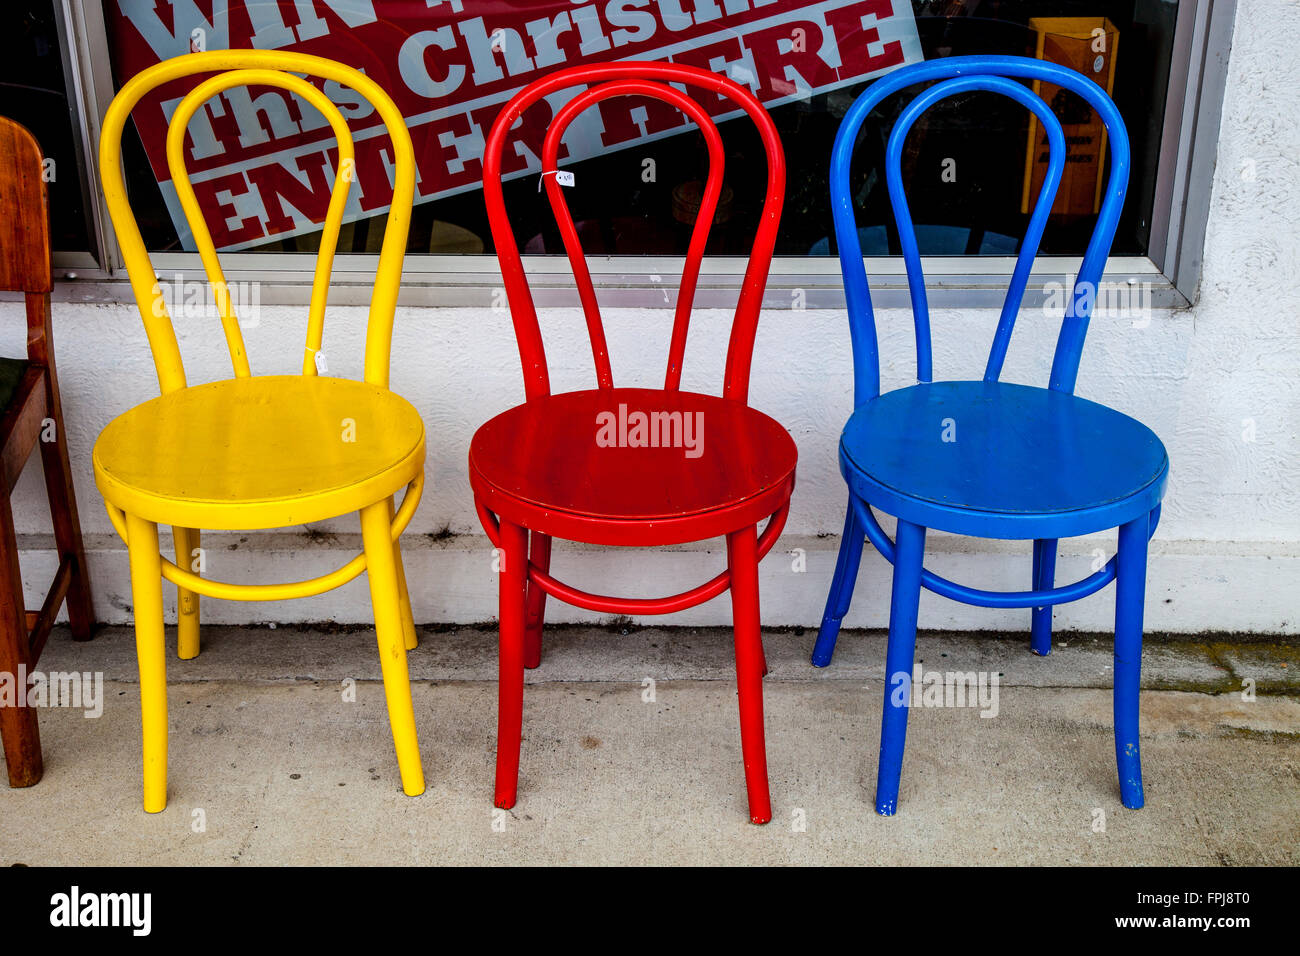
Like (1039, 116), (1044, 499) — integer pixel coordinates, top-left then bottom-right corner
(0, 117), (95, 787)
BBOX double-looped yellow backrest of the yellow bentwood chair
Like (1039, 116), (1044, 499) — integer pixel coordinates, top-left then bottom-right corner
(99, 49), (415, 394)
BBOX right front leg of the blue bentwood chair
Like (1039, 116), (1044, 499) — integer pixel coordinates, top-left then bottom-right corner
(1114, 515), (1149, 810)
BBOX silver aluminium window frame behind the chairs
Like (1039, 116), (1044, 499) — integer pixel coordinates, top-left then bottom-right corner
(45, 0), (1236, 310)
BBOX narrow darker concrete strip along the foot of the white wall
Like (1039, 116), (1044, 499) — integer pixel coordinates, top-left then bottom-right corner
(32, 624), (1300, 695)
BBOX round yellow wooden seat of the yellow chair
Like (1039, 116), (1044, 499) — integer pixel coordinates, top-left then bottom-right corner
(94, 376), (425, 531)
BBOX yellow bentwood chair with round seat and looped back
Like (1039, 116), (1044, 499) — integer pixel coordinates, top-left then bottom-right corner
(94, 49), (425, 813)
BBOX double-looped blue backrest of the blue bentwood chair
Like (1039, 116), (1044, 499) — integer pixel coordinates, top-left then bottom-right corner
(831, 56), (1128, 407)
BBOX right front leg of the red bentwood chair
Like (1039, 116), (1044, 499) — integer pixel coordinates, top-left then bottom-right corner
(727, 525), (772, 823)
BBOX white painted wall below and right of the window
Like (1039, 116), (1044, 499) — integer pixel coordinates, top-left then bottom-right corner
(0, 0), (1300, 633)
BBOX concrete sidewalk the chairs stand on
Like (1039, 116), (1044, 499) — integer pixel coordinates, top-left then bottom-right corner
(0, 627), (1300, 865)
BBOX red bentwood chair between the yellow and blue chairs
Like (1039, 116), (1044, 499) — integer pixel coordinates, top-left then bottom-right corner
(469, 62), (797, 823)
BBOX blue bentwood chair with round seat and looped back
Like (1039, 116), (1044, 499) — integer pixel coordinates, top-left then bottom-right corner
(813, 56), (1169, 816)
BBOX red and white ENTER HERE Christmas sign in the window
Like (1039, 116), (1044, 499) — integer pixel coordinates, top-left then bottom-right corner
(107, 0), (922, 250)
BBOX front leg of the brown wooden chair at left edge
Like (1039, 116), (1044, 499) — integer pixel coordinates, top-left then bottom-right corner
(0, 494), (44, 787)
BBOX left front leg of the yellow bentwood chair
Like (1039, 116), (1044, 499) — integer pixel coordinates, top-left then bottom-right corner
(126, 514), (166, 813)
